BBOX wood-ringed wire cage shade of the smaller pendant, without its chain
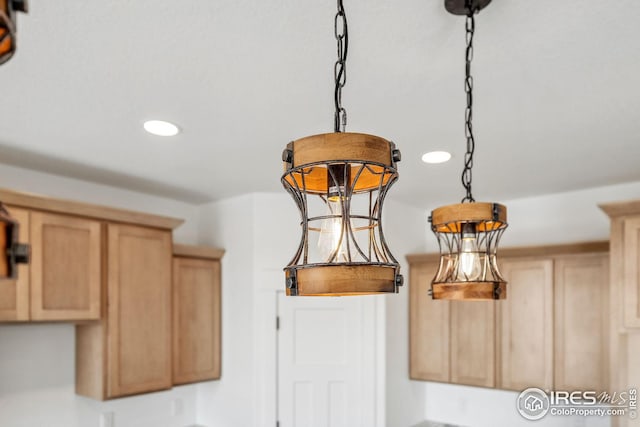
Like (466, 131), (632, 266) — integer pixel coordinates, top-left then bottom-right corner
(429, 202), (508, 300)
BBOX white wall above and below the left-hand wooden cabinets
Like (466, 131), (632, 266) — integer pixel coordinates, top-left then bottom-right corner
(0, 165), (198, 427)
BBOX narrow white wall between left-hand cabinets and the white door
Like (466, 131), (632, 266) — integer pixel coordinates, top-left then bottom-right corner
(196, 195), (255, 427)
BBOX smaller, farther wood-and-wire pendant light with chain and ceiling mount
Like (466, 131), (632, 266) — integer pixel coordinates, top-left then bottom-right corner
(429, 0), (507, 300)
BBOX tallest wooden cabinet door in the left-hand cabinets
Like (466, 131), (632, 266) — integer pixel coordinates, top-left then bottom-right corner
(107, 224), (172, 398)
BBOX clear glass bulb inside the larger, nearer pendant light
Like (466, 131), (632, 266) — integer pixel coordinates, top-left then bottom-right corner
(318, 197), (348, 262)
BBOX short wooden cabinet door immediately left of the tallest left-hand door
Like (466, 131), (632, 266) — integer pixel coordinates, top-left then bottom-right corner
(31, 212), (102, 320)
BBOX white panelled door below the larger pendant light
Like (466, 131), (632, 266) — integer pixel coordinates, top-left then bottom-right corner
(278, 293), (368, 427)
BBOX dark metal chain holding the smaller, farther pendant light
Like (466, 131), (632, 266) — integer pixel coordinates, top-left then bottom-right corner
(462, 0), (476, 203)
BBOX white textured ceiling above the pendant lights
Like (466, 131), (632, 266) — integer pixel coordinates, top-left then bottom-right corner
(0, 0), (640, 208)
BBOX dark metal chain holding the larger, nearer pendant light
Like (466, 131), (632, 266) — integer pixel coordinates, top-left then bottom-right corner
(333, 0), (349, 132)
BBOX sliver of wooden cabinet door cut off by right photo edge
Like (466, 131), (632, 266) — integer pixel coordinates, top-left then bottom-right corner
(623, 218), (640, 328)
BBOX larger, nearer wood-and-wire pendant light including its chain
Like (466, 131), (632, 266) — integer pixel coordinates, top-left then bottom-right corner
(281, 0), (402, 296)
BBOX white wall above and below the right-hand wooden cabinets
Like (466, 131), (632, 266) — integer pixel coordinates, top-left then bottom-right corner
(420, 182), (640, 427)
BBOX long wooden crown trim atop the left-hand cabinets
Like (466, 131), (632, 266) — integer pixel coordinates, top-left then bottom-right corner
(0, 189), (184, 230)
